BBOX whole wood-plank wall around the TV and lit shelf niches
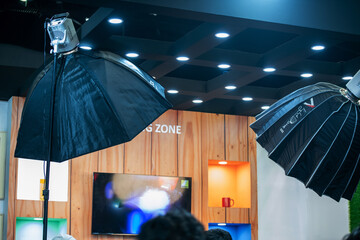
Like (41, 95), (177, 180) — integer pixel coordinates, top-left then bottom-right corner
(7, 97), (258, 240)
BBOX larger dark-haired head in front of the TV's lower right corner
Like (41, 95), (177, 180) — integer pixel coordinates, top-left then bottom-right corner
(138, 209), (205, 240)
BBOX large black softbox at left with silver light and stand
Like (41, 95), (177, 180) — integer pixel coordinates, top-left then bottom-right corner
(15, 14), (171, 239)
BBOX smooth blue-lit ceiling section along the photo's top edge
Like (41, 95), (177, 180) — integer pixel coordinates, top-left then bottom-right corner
(117, 0), (360, 34)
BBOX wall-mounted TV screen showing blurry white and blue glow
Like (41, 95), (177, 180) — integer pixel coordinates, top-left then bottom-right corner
(91, 173), (191, 235)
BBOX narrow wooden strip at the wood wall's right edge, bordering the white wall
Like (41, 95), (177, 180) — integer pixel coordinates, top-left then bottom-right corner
(248, 117), (258, 240)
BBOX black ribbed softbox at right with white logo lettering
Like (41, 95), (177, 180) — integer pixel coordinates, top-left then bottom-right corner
(250, 73), (360, 201)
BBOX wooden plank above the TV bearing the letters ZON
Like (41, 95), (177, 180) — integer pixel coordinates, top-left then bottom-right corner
(151, 110), (177, 176)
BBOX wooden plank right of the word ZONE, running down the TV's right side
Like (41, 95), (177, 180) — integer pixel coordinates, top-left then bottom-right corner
(178, 111), (202, 220)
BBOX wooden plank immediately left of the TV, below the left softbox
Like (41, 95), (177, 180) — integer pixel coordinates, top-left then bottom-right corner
(71, 152), (99, 240)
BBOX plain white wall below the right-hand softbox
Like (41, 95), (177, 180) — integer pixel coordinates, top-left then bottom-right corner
(257, 144), (349, 240)
